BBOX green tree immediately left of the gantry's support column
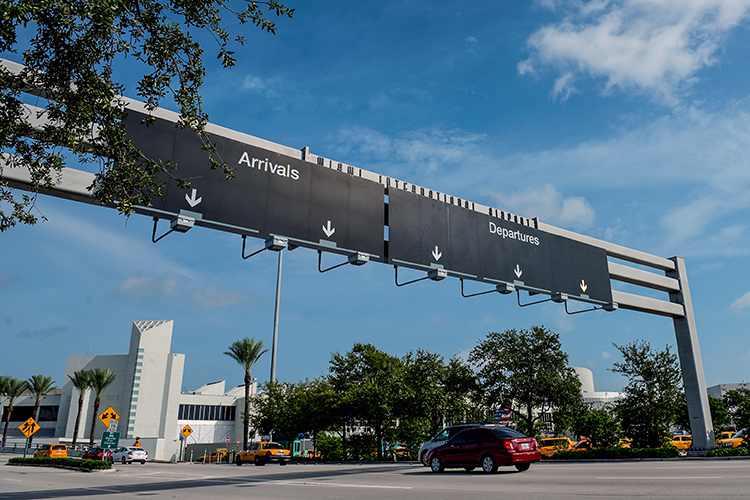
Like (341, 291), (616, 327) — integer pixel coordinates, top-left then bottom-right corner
(611, 340), (684, 448)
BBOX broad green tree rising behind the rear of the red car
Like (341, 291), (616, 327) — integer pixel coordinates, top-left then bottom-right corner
(469, 326), (582, 436)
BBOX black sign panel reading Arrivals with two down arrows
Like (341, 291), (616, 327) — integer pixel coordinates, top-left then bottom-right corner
(126, 112), (385, 260)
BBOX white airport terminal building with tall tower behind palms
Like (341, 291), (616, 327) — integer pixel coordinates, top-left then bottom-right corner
(1, 321), (257, 460)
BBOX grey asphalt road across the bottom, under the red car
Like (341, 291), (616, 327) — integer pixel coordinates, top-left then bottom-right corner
(0, 456), (750, 500)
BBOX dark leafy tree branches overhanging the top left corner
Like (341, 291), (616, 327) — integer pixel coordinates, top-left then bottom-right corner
(0, 0), (294, 231)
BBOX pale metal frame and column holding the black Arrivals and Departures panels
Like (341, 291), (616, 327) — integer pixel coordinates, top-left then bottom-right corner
(0, 59), (715, 450)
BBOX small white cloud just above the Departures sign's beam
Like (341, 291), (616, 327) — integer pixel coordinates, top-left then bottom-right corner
(493, 184), (596, 229)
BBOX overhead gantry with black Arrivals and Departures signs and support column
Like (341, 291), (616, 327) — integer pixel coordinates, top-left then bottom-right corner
(0, 60), (714, 450)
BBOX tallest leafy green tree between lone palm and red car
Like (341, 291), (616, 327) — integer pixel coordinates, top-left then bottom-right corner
(329, 342), (403, 458)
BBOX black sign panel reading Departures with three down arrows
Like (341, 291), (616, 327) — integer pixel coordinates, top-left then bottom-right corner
(388, 189), (612, 302)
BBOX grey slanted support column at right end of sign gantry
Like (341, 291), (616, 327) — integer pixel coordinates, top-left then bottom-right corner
(666, 257), (716, 450)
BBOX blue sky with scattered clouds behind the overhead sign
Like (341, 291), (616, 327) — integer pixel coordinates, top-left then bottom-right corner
(0, 0), (750, 391)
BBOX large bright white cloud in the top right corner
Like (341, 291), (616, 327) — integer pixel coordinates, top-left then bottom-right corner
(518, 0), (750, 104)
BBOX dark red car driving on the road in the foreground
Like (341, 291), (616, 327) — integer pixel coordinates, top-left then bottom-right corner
(427, 427), (542, 472)
